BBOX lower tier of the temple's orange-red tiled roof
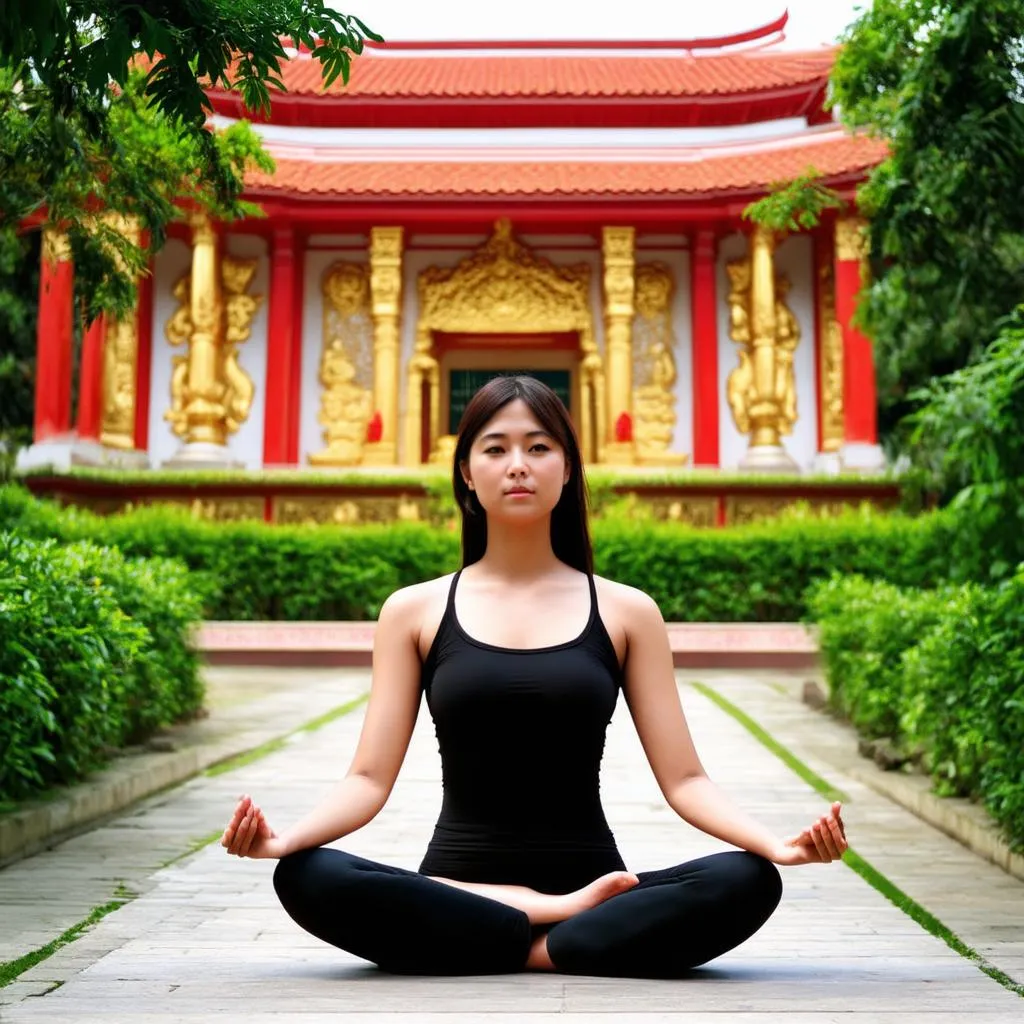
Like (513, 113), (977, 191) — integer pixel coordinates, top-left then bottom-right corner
(246, 132), (886, 199)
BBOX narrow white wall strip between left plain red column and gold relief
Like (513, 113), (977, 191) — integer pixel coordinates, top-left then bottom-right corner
(298, 234), (370, 468)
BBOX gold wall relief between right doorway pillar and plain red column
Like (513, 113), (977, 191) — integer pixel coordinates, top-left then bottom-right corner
(633, 263), (686, 465)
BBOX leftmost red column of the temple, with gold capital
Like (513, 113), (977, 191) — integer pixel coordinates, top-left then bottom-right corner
(33, 229), (75, 444)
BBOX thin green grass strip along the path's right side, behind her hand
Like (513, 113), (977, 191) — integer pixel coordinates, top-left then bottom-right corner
(692, 683), (1024, 996)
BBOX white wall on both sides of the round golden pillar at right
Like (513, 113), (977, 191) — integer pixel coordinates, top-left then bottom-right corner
(716, 231), (818, 471)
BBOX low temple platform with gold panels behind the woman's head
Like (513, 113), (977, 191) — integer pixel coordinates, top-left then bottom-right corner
(23, 467), (900, 527)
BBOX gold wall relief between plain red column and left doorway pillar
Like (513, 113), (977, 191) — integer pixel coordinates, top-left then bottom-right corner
(309, 263), (373, 466)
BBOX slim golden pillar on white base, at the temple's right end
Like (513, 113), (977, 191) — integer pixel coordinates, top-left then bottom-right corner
(739, 224), (799, 472)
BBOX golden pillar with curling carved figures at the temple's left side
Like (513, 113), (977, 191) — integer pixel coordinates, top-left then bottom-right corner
(164, 215), (263, 446)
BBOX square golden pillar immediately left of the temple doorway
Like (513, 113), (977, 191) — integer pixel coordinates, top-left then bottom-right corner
(362, 227), (408, 466)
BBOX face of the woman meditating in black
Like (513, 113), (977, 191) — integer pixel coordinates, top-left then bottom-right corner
(461, 398), (570, 520)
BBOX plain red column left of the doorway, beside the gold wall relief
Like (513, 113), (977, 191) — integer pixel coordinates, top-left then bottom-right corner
(263, 227), (295, 466)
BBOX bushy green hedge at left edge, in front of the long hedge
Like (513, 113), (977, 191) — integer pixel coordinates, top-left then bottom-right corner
(0, 534), (203, 801)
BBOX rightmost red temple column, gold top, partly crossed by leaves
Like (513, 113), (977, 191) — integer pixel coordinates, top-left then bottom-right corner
(836, 218), (879, 444)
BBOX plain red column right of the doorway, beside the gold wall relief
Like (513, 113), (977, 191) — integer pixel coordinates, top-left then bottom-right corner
(690, 231), (719, 466)
